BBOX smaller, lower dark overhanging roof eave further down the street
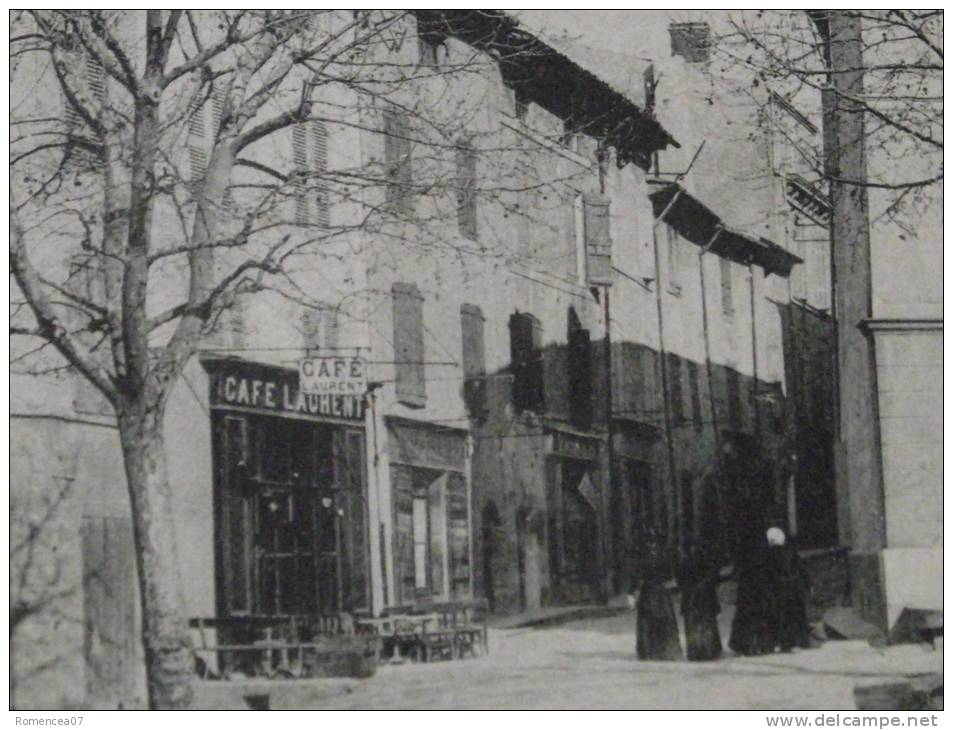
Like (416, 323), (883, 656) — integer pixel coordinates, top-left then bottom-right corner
(649, 182), (803, 277)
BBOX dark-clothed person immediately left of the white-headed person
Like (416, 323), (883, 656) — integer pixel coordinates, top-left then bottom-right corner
(728, 533), (776, 656)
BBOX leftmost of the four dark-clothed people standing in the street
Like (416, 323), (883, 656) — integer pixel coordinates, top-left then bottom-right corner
(635, 531), (682, 661)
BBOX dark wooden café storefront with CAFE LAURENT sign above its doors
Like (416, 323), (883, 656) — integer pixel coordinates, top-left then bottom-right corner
(202, 359), (371, 618)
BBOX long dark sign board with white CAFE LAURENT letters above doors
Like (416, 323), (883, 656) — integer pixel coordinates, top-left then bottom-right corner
(202, 359), (364, 421)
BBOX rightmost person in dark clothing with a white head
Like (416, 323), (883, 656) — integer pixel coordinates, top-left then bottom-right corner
(767, 527), (809, 652)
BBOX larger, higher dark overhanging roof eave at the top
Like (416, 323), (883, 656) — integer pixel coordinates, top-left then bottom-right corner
(413, 10), (680, 169)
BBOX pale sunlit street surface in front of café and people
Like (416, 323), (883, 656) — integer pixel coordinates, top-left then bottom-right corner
(195, 613), (942, 710)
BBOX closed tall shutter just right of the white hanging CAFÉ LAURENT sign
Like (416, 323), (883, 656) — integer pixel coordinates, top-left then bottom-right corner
(391, 282), (427, 408)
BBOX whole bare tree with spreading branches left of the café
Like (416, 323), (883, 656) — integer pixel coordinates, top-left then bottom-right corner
(10, 10), (604, 708)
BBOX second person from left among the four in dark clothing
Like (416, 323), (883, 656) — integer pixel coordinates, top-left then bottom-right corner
(678, 542), (722, 661)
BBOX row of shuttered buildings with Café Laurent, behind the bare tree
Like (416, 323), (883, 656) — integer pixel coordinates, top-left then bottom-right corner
(11, 10), (932, 708)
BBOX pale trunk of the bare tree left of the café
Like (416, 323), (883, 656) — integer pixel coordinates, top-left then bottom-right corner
(119, 403), (194, 709)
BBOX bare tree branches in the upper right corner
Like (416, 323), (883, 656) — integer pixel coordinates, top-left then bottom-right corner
(714, 10), (943, 230)
